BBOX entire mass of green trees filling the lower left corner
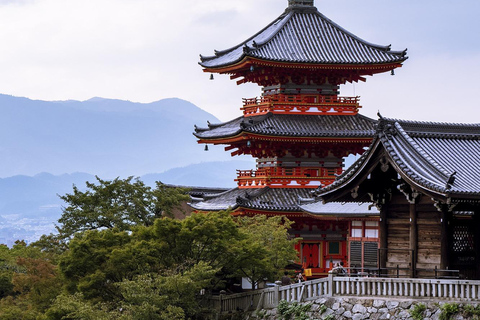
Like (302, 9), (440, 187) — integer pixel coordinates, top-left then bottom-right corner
(0, 178), (296, 320)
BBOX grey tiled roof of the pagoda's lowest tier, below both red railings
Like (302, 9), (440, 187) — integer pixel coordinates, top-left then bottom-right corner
(190, 187), (312, 212)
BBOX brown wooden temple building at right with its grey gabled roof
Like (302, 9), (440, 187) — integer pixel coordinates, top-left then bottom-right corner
(310, 117), (480, 279)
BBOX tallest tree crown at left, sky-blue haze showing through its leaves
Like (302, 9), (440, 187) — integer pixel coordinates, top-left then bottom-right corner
(57, 177), (189, 238)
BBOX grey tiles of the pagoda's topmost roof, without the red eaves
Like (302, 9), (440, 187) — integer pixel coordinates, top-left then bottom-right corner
(200, 6), (407, 68)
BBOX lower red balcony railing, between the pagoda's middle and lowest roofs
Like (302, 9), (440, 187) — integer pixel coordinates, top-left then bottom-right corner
(235, 167), (342, 188)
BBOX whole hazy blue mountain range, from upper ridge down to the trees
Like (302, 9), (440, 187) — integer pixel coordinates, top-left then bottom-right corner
(0, 95), (254, 245)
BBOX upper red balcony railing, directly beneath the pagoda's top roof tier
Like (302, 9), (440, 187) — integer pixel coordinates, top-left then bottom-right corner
(242, 94), (360, 116)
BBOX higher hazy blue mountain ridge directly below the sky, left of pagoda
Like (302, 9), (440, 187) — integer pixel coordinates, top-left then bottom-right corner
(0, 95), (230, 177)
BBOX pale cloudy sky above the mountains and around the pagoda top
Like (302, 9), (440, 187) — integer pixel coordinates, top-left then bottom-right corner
(0, 0), (480, 125)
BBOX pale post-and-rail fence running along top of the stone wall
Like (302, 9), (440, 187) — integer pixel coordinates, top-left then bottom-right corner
(207, 274), (480, 312)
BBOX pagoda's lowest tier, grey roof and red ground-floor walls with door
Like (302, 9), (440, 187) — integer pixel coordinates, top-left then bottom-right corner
(190, 187), (379, 278)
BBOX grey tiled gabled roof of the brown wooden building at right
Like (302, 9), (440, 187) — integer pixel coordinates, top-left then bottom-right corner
(317, 118), (480, 200)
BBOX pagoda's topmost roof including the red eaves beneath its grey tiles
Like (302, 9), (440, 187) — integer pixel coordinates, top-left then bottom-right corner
(200, 1), (407, 86)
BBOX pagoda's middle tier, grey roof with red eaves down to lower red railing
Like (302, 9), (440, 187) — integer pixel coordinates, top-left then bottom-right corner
(195, 112), (375, 189)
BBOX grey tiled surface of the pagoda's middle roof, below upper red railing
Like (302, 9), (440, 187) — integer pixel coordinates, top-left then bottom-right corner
(194, 113), (376, 139)
